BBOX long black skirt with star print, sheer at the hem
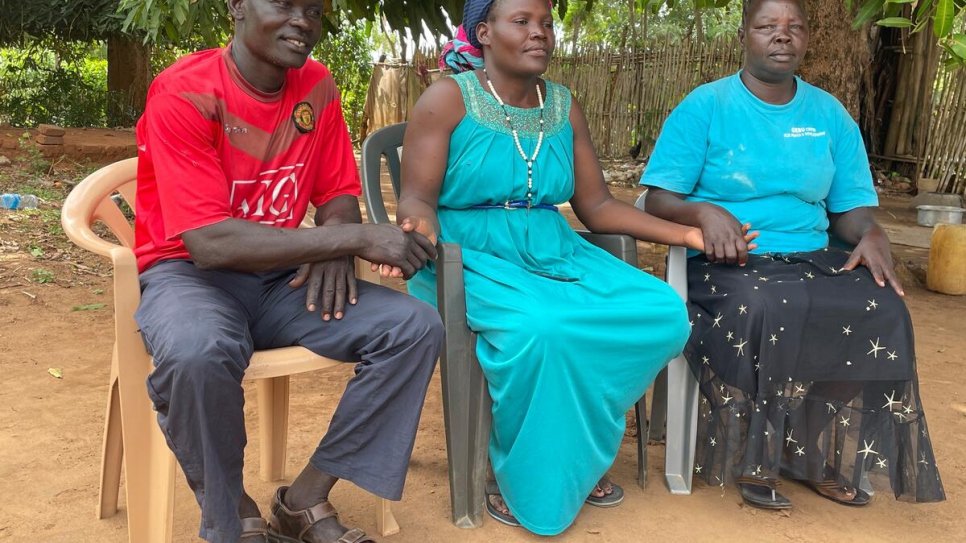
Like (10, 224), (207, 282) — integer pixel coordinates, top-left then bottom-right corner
(685, 248), (945, 501)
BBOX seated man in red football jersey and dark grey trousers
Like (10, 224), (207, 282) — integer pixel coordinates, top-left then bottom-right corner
(135, 0), (443, 543)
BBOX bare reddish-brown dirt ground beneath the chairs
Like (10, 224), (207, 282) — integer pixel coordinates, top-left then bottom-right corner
(0, 141), (966, 543)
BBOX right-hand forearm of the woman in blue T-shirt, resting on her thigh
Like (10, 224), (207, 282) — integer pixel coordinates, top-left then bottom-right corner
(829, 207), (905, 296)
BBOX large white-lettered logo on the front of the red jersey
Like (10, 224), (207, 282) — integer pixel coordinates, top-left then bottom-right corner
(231, 164), (305, 224)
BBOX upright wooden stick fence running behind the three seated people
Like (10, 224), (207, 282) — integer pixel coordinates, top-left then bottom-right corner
(367, 36), (966, 195)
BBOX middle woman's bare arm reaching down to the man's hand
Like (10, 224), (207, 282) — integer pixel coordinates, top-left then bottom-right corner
(396, 77), (466, 242)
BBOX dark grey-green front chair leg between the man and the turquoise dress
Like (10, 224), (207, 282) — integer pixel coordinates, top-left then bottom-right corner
(440, 338), (492, 528)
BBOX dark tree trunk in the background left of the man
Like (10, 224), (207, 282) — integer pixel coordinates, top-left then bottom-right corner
(107, 36), (151, 126)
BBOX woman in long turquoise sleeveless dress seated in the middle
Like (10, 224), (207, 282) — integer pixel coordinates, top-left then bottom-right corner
(397, 0), (748, 535)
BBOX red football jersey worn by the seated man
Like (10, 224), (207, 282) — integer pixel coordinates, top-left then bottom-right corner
(134, 45), (361, 272)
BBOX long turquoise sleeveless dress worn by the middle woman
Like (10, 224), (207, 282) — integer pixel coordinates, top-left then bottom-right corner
(409, 72), (690, 535)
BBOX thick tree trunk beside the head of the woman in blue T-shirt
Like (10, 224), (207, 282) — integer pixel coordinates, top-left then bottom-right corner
(799, 0), (873, 119)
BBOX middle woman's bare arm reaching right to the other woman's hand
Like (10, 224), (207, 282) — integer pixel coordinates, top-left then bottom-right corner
(570, 96), (704, 251)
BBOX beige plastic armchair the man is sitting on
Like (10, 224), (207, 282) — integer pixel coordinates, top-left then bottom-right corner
(61, 158), (399, 543)
